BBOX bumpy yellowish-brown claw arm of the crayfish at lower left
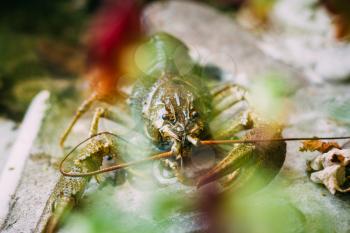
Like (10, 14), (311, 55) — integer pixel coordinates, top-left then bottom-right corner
(42, 135), (118, 233)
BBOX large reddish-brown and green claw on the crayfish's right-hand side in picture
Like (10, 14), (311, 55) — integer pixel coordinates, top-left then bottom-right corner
(197, 125), (286, 190)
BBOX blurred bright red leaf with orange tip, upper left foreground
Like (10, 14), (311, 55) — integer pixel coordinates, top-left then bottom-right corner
(87, 0), (143, 96)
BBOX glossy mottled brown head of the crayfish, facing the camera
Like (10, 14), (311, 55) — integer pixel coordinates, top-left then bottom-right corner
(143, 77), (207, 156)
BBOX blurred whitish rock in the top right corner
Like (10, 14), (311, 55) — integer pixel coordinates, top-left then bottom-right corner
(259, 0), (350, 83)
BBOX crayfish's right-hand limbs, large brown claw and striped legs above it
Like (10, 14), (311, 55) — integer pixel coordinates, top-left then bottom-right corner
(197, 83), (286, 190)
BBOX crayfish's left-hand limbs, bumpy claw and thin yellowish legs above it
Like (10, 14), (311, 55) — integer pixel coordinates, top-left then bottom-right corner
(37, 99), (129, 233)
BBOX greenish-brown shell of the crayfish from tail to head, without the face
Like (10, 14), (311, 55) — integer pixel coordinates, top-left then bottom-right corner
(130, 33), (211, 148)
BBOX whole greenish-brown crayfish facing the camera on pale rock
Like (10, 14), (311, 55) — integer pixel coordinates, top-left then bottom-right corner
(40, 33), (350, 232)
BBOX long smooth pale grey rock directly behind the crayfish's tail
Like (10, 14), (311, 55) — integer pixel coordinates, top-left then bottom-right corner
(144, 1), (305, 90)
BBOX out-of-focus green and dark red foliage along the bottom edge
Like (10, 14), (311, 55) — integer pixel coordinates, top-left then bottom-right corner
(62, 183), (308, 233)
